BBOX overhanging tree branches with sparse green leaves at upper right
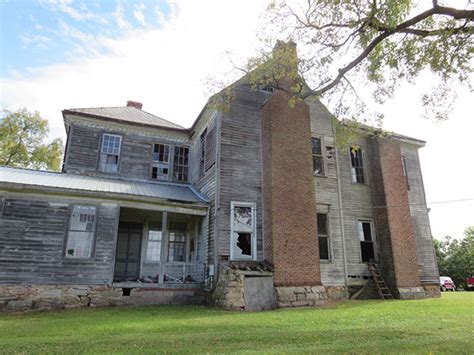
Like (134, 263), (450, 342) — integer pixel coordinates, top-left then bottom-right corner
(231, 0), (474, 124)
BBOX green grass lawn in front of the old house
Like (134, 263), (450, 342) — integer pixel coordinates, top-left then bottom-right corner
(0, 292), (474, 353)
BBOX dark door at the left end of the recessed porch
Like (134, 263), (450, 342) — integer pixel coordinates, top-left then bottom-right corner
(114, 223), (143, 281)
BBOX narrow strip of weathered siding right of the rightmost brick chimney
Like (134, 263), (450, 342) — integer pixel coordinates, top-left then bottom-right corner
(401, 144), (439, 283)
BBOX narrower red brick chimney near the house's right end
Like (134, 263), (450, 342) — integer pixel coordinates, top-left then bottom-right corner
(371, 137), (424, 298)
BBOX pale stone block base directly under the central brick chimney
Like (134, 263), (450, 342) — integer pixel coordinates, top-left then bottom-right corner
(275, 286), (328, 308)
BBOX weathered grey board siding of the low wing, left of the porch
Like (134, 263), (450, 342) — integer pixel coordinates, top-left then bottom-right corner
(0, 196), (118, 285)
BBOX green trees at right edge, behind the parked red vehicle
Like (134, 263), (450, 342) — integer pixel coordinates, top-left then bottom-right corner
(433, 227), (474, 288)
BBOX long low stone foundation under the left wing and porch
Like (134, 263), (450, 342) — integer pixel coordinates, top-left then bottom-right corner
(0, 285), (204, 312)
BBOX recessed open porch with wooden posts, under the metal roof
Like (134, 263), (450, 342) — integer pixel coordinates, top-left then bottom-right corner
(112, 208), (206, 290)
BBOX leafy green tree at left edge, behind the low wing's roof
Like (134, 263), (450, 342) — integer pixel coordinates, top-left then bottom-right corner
(0, 109), (63, 171)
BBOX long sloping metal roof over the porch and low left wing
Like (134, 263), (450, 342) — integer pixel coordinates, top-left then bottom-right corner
(0, 166), (209, 205)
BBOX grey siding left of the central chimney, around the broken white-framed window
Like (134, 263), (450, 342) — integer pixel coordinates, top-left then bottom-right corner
(219, 85), (270, 260)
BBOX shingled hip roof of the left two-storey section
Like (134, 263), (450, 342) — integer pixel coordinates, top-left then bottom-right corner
(63, 106), (186, 131)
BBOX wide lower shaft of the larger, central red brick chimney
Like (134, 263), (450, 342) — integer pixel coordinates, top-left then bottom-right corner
(261, 91), (321, 286)
